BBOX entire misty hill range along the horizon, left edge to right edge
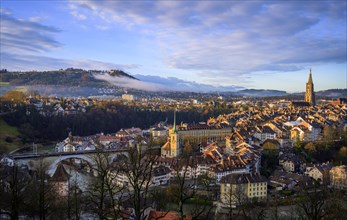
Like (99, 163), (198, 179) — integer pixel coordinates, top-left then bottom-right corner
(0, 68), (347, 98)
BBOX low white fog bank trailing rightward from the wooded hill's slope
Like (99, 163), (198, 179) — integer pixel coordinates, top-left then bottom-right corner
(94, 74), (243, 92)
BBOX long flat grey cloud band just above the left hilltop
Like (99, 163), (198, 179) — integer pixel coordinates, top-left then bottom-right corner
(0, 53), (139, 71)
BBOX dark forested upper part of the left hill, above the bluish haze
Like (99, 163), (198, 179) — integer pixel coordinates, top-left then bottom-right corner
(0, 68), (136, 88)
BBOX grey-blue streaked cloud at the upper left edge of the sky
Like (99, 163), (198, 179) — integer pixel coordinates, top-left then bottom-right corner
(0, 9), (62, 53)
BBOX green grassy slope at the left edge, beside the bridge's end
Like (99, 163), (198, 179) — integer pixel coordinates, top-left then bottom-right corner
(0, 117), (22, 152)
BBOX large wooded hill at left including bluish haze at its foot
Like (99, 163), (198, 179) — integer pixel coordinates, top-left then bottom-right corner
(0, 68), (137, 97)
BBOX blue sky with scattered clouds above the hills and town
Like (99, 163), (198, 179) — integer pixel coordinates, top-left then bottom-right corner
(0, 0), (347, 92)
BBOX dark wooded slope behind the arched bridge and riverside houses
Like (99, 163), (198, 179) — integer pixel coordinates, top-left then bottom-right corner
(2, 101), (220, 142)
